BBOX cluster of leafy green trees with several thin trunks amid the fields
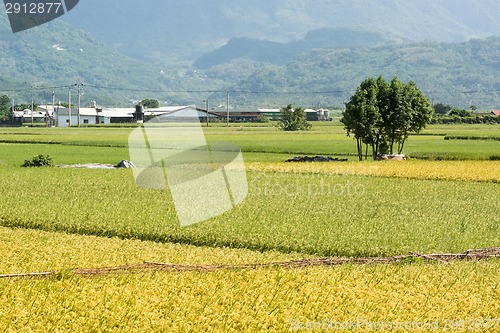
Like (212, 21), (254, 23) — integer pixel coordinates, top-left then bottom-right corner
(341, 76), (434, 161)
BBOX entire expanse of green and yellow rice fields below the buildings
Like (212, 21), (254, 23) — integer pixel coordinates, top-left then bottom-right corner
(0, 125), (500, 332)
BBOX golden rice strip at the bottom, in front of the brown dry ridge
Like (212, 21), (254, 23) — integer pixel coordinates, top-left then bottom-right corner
(0, 262), (500, 332)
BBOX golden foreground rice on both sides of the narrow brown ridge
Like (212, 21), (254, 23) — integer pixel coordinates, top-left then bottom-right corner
(0, 228), (500, 332)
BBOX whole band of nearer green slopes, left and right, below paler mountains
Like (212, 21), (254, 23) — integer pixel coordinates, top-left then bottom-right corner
(0, 8), (500, 109)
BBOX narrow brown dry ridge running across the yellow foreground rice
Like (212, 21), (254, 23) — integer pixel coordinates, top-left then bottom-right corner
(0, 247), (500, 278)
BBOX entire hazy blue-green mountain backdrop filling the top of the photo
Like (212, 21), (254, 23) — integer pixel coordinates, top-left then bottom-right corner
(0, 0), (500, 108)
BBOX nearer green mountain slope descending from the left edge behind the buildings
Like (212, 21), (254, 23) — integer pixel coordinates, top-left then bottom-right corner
(0, 13), (229, 106)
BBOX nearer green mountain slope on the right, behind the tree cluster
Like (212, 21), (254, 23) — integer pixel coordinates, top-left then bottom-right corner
(226, 37), (500, 109)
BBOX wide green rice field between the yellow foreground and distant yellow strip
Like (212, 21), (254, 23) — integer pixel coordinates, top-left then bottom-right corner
(0, 167), (500, 257)
